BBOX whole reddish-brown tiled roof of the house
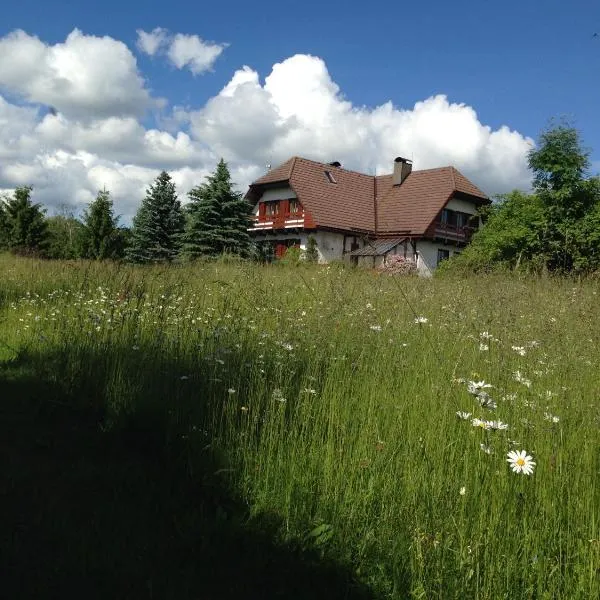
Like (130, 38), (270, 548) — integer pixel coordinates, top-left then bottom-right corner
(247, 156), (488, 235)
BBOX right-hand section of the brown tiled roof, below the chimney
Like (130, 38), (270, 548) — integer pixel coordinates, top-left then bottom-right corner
(377, 167), (488, 236)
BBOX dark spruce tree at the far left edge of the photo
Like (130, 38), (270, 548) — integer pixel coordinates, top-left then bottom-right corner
(5, 186), (48, 255)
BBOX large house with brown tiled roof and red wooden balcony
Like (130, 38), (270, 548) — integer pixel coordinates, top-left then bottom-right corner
(246, 156), (490, 275)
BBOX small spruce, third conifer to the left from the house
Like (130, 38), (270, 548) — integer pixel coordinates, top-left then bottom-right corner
(81, 190), (119, 260)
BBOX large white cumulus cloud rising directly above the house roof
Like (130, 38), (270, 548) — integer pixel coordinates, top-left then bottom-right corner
(190, 54), (533, 194)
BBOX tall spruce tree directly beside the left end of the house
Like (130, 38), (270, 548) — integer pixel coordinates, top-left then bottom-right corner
(183, 159), (252, 258)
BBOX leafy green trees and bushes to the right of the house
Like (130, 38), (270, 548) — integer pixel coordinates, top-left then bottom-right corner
(444, 121), (600, 273)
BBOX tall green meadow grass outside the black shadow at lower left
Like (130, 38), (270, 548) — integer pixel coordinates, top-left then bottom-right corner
(0, 257), (600, 599)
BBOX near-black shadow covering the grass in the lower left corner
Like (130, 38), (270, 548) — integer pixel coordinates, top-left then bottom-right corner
(0, 352), (374, 599)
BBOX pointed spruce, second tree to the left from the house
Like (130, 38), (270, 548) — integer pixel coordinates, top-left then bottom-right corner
(127, 171), (184, 263)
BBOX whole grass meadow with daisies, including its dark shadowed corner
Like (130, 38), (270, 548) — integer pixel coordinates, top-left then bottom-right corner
(0, 256), (600, 600)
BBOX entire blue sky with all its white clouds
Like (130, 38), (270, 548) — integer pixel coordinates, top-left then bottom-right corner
(0, 0), (600, 223)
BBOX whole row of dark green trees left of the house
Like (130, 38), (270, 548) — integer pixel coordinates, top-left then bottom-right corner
(0, 159), (253, 263)
